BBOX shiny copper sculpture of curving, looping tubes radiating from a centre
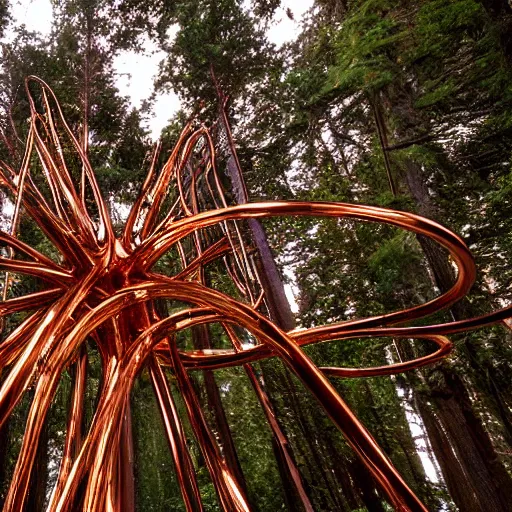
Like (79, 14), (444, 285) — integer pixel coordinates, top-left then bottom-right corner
(0, 77), (511, 512)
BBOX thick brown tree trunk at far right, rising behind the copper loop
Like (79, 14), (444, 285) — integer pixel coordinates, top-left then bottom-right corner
(380, 90), (512, 512)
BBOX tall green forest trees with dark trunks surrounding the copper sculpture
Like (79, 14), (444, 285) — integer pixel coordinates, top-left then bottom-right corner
(0, 0), (512, 512)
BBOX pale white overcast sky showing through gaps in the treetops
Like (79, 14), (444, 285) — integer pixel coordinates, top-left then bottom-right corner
(7, 0), (313, 139)
